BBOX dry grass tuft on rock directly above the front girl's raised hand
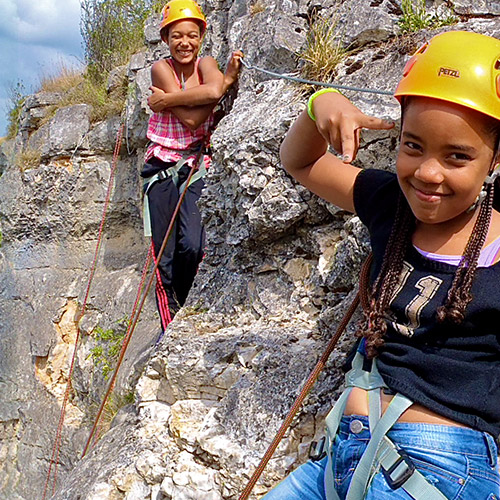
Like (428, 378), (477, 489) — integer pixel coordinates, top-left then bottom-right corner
(296, 17), (347, 82)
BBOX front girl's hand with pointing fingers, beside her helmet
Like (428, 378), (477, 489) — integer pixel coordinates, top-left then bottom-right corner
(313, 92), (394, 163)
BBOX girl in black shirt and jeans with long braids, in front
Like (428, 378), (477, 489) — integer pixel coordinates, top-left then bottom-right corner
(264, 32), (500, 500)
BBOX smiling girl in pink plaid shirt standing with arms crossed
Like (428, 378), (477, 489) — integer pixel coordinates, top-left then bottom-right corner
(141, 0), (241, 331)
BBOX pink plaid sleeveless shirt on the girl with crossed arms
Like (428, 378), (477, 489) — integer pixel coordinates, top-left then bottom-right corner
(144, 59), (214, 168)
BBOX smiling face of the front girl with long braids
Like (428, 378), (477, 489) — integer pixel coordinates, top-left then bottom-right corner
(396, 97), (495, 224)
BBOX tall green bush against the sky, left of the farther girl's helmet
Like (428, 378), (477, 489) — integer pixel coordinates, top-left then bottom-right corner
(80, 0), (152, 81)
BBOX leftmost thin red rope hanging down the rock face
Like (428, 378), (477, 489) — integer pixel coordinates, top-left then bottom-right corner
(42, 124), (124, 500)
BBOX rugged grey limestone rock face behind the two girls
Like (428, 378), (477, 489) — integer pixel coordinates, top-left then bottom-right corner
(0, 0), (500, 500)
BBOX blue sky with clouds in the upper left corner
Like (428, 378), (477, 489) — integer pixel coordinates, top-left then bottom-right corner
(0, 0), (83, 137)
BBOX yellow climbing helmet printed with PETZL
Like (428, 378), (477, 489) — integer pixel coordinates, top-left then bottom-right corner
(394, 31), (500, 120)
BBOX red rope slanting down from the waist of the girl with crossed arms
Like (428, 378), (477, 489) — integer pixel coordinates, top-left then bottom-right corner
(82, 141), (205, 458)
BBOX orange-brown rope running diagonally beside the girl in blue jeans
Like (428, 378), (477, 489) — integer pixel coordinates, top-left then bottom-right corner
(239, 254), (372, 500)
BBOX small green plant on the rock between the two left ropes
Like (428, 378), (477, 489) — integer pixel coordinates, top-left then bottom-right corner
(87, 318), (128, 380)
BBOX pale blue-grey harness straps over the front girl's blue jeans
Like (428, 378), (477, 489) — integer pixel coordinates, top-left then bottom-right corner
(325, 352), (447, 500)
